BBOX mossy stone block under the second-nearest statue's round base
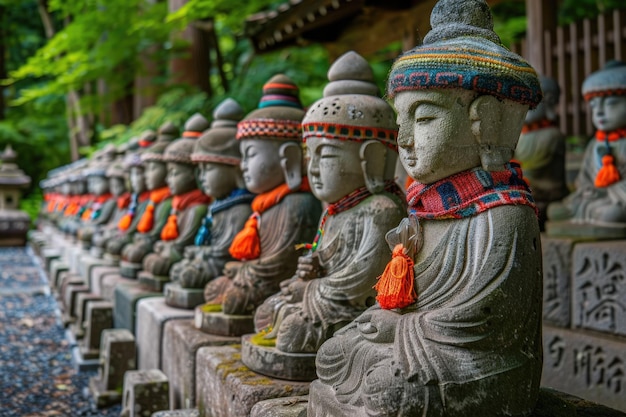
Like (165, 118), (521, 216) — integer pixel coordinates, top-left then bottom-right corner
(196, 345), (309, 417)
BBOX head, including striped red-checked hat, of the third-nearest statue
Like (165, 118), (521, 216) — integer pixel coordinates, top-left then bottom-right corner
(237, 74), (304, 193)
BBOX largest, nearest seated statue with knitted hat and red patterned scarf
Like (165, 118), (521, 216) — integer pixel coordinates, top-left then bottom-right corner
(308, 0), (542, 417)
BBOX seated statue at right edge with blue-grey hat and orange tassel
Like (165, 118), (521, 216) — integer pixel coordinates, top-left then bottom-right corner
(547, 61), (626, 237)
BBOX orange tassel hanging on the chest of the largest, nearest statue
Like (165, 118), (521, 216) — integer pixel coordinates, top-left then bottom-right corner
(374, 243), (417, 310)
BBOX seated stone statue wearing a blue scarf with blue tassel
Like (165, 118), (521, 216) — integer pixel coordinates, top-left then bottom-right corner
(170, 99), (254, 288)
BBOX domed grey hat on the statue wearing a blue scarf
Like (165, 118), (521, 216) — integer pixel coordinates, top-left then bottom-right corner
(191, 98), (243, 165)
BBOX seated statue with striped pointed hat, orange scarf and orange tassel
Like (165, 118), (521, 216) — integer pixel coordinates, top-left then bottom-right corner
(205, 75), (321, 315)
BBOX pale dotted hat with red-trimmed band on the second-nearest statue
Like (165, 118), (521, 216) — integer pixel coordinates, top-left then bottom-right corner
(302, 51), (398, 150)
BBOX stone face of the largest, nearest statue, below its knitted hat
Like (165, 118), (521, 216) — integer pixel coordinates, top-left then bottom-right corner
(394, 89), (481, 184)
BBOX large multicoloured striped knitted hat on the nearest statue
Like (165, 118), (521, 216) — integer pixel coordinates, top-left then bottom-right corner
(387, 0), (542, 108)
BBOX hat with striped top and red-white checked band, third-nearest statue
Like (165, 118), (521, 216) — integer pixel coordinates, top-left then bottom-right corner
(237, 74), (304, 141)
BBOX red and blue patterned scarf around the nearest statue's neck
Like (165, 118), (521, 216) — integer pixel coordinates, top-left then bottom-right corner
(407, 162), (537, 220)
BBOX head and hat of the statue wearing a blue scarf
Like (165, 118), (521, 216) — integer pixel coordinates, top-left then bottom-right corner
(191, 98), (245, 199)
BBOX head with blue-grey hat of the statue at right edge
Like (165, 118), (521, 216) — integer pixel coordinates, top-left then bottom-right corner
(582, 61), (626, 132)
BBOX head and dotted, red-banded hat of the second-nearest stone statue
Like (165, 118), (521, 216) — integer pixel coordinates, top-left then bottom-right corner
(302, 52), (398, 203)
